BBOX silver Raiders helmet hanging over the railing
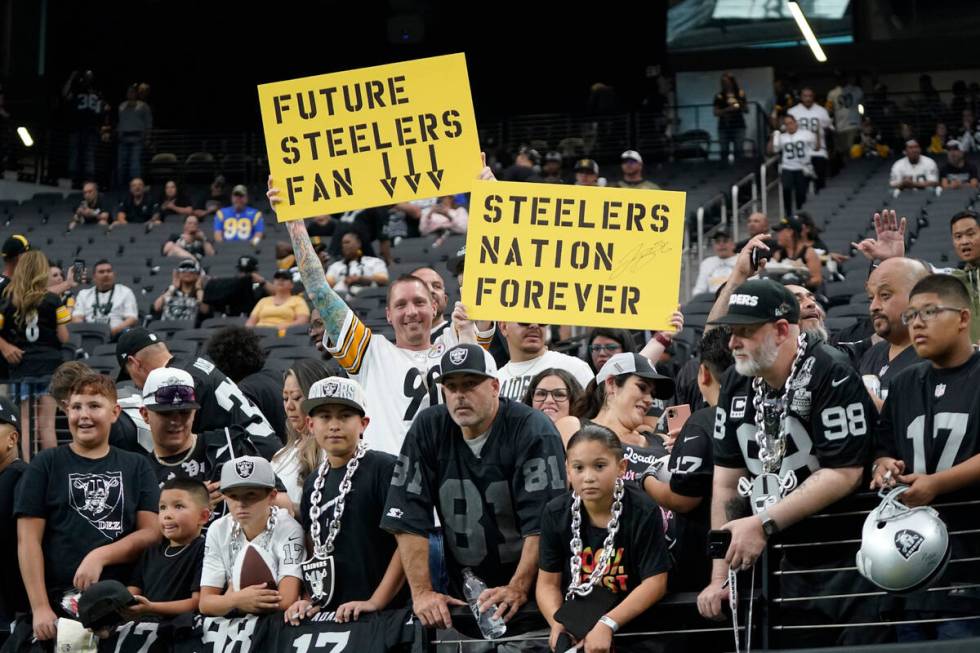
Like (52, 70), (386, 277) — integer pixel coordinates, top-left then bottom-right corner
(857, 485), (949, 594)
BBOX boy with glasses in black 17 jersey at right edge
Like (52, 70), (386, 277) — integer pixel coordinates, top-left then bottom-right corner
(871, 274), (980, 641)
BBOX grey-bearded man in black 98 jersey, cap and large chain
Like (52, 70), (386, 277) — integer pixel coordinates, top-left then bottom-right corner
(698, 272), (877, 641)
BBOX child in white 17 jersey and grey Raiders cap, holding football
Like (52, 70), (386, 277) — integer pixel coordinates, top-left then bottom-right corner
(199, 456), (306, 617)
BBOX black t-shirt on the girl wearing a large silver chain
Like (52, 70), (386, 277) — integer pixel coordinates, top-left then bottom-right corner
(538, 483), (670, 601)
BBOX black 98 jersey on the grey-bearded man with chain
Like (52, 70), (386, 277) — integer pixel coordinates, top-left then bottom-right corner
(714, 337), (878, 486)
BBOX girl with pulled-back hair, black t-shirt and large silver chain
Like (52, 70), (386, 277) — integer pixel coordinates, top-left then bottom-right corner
(536, 423), (668, 653)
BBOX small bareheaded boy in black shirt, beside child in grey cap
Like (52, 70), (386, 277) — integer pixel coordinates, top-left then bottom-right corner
(124, 478), (211, 620)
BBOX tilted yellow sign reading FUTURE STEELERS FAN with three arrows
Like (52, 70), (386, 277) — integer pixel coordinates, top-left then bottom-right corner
(259, 54), (481, 221)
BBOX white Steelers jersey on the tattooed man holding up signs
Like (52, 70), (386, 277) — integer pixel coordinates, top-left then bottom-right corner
(323, 310), (489, 456)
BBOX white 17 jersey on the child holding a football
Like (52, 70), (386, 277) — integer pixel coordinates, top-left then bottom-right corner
(201, 509), (306, 592)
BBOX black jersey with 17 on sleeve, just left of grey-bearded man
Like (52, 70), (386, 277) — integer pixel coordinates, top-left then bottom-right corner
(668, 406), (715, 592)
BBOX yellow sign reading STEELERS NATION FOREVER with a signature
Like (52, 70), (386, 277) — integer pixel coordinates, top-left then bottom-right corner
(462, 181), (685, 329)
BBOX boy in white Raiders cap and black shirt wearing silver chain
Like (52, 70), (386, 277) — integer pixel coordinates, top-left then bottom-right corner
(286, 376), (407, 625)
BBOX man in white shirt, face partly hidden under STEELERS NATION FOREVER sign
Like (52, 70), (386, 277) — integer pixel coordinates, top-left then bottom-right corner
(497, 322), (595, 401)
